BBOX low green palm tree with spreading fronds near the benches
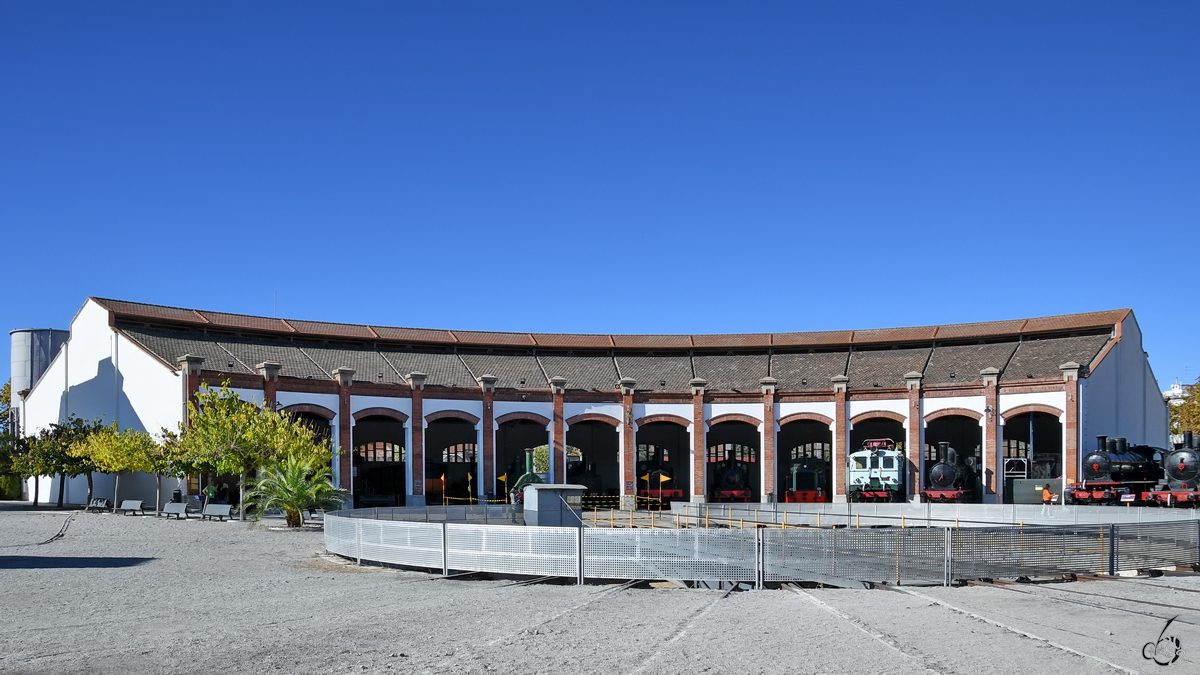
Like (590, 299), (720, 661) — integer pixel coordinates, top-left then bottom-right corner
(246, 453), (350, 527)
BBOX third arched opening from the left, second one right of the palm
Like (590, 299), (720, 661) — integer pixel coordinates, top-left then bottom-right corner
(425, 417), (479, 506)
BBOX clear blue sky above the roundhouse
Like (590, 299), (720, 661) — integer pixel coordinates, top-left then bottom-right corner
(0, 1), (1200, 388)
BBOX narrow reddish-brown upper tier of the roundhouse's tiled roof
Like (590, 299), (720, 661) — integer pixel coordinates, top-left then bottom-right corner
(92, 298), (1129, 351)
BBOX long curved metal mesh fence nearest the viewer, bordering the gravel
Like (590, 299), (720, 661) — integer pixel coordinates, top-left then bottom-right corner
(325, 507), (1200, 584)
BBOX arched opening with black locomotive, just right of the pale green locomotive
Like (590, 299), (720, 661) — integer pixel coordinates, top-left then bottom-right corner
(922, 414), (983, 503)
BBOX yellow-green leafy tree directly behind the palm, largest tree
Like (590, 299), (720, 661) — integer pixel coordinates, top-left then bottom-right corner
(178, 386), (329, 518)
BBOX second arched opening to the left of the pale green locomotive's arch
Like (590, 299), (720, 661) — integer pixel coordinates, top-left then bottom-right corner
(704, 422), (762, 502)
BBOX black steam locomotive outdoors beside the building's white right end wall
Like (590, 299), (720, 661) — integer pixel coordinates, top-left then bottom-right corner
(1067, 436), (1161, 504)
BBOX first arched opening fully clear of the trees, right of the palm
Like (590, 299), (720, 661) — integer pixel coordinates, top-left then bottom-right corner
(350, 416), (408, 508)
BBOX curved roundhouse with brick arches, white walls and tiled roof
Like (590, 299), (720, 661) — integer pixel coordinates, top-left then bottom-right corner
(13, 298), (1168, 508)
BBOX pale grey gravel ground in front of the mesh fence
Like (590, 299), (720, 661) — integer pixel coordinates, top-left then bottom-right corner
(0, 504), (1200, 675)
